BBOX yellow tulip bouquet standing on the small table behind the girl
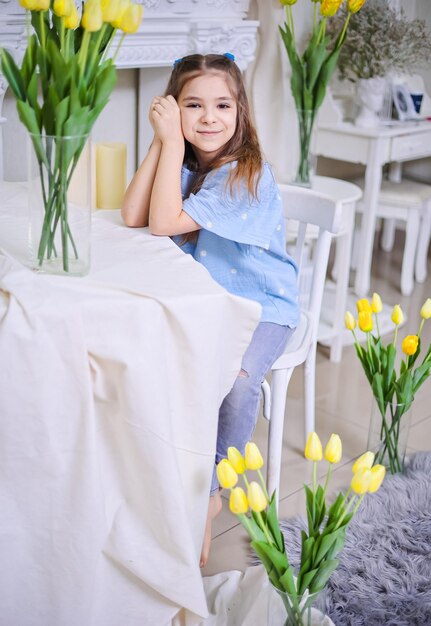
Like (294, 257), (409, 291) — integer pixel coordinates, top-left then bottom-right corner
(279, 0), (365, 184)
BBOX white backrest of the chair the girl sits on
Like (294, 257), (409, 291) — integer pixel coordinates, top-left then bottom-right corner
(278, 184), (342, 339)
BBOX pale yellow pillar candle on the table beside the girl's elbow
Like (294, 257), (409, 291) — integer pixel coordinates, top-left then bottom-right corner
(96, 142), (127, 209)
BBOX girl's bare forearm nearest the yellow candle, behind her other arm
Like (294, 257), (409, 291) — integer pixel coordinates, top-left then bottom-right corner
(121, 137), (162, 227)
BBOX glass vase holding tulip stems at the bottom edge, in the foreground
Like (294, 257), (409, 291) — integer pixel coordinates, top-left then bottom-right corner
(267, 585), (332, 626)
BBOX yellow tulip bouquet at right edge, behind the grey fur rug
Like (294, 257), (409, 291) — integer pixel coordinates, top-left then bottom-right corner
(345, 293), (431, 474)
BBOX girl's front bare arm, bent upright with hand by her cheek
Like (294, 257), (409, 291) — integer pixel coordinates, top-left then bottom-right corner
(149, 96), (200, 235)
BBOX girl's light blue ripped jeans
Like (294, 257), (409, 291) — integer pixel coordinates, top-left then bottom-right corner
(210, 322), (295, 495)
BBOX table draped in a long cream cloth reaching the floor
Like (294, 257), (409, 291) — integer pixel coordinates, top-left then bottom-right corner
(0, 184), (260, 626)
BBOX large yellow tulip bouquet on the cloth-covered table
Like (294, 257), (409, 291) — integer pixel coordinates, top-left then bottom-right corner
(1, 0), (142, 272)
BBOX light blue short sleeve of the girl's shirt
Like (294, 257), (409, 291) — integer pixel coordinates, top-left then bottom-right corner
(183, 163), (280, 248)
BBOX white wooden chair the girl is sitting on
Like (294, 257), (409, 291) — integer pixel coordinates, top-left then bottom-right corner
(262, 185), (342, 494)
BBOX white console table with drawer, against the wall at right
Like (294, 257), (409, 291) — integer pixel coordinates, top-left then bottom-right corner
(314, 121), (431, 297)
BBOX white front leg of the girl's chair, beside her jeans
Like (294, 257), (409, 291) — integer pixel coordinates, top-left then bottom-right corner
(267, 367), (294, 505)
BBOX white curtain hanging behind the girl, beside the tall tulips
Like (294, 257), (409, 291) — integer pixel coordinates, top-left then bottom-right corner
(246, 0), (313, 183)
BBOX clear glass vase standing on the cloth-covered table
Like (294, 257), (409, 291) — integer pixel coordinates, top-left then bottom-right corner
(28, 134), (91, 276)
